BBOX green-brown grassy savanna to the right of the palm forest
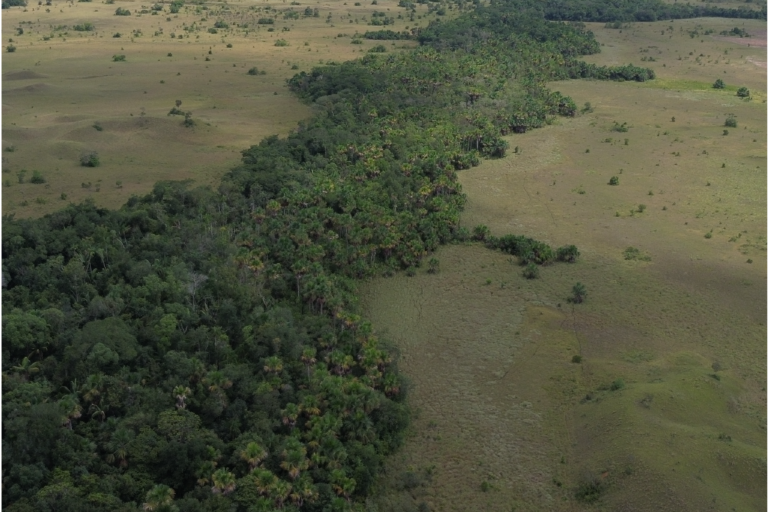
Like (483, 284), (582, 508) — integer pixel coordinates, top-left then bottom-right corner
(364, 19), (768, 511)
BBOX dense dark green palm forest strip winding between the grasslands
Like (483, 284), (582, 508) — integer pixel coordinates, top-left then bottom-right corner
(9, 1), (752, 512)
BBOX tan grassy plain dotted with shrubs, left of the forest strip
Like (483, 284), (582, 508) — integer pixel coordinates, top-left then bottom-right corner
(0, 0), (426, 216)
